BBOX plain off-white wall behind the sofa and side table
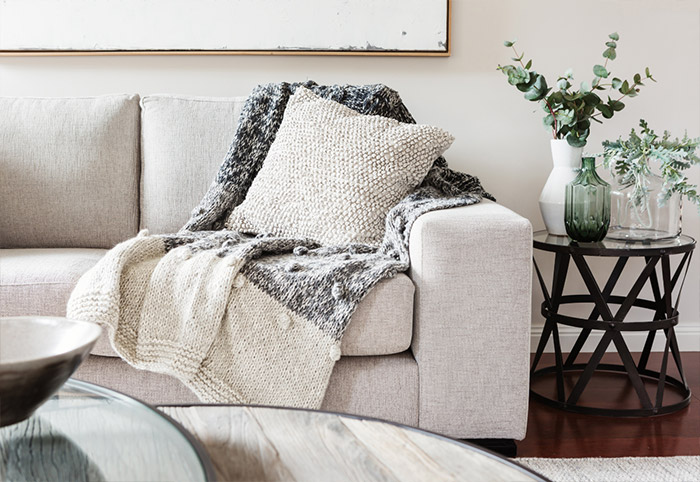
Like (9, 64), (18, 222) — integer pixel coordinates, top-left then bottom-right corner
(0, 0), (700, 351)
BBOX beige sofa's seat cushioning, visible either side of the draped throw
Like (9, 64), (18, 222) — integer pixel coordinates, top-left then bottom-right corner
(0, 248), (414, 356)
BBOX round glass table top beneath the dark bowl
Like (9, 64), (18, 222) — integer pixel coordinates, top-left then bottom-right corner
(0, 379), (214, 481)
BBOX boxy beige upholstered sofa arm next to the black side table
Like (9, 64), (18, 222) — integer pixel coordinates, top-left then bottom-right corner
(410, 200), (532, 440)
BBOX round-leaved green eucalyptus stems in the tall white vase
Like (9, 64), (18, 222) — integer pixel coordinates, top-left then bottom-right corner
(498, 32), (656, 147)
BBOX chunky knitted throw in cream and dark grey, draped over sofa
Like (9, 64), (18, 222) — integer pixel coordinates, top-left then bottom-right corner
(68, 82), (490, 408)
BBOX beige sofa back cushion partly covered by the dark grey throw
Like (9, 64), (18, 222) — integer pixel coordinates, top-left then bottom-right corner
(141, 95), (246, 234)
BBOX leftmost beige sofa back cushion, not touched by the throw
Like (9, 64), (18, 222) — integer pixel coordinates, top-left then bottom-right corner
(0, 95), (139, 248)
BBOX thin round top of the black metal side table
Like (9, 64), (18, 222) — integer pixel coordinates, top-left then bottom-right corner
(532, 230), (695, 256)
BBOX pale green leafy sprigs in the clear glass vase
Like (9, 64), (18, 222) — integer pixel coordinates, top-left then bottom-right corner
(603, 119), (700, 207)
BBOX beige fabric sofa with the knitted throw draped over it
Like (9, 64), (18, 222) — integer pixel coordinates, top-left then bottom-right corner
(0, 95), (532, 439)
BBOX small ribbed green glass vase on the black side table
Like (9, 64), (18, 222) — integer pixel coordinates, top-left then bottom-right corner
(564, 157), (610, 242)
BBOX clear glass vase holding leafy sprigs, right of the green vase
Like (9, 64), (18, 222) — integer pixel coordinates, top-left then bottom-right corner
(608, 173), (681, 241)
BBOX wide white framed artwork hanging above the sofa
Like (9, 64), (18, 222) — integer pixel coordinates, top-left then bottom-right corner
(0, 0), (451, 56)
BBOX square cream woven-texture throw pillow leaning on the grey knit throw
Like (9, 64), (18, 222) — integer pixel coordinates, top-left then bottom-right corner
(226, 87), (453, 245)
